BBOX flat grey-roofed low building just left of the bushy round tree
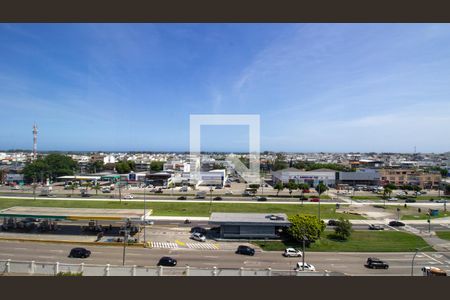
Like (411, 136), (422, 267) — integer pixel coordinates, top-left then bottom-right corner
(209, 213), (291, 239)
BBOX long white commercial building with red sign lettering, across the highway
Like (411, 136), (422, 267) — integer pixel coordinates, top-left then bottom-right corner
(272, 168), (336, 187)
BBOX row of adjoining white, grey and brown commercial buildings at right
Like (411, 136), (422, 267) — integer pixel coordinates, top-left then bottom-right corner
(272, 168), (442, 189)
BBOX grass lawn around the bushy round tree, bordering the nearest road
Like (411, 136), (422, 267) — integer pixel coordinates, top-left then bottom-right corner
(255, 231), (432, 252)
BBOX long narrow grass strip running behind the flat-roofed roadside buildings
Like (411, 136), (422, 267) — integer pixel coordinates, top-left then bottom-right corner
(0, 199), (364, 219)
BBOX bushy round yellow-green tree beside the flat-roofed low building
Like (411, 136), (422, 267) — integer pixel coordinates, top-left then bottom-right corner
(287, 214), (326, 242)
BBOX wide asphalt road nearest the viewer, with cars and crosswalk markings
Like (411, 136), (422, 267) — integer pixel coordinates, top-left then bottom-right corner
(0, 241), (450, 276)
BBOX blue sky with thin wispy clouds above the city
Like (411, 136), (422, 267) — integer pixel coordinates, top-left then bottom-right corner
(0, 24), (450, 152)
